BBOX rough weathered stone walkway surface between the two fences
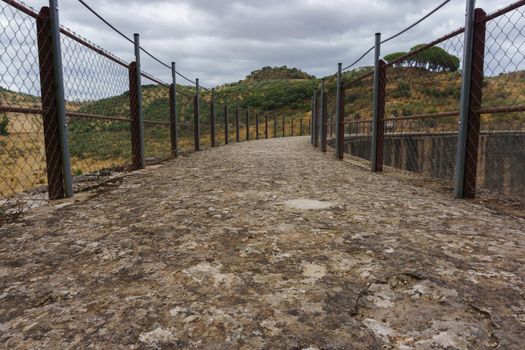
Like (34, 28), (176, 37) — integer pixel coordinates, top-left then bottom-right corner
(0, 138), (525, 349)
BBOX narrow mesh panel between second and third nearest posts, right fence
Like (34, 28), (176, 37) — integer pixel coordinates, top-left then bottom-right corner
(342, 73), (374, 161)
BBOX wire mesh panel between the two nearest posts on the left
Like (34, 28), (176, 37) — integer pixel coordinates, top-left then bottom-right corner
(61, 29), (131, 175)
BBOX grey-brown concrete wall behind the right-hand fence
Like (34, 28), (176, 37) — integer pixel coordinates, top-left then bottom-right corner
(330, 131), (525, 199)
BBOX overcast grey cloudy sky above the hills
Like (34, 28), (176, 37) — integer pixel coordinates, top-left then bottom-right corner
(14, 0), (512, 86)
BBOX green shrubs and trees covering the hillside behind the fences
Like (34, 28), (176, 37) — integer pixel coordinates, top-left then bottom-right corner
(0, 60), (525, 179)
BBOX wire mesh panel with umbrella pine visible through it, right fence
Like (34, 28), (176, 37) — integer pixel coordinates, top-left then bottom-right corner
(383, 30), (464, 183)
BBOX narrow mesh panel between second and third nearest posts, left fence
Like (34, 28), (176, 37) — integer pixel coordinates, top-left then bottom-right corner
(141, 74), (171, 163)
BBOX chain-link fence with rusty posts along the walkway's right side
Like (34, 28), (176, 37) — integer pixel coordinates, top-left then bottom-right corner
(312, 1), (525, 201)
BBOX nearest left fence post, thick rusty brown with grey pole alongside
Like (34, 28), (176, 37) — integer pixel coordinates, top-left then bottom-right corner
(36, 2), (73, 199)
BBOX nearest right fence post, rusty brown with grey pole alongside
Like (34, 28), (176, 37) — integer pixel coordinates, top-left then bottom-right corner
(454, 0), (486, 198)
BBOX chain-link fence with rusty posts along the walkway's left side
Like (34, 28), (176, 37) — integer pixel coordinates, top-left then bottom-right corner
(0, 0), (310, 220)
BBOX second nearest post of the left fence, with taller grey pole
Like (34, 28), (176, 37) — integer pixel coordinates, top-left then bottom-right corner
(129, 33), (146, 170)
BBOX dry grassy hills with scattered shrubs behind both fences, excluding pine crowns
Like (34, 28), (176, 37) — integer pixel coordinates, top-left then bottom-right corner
(0, 67), (525, 200)
